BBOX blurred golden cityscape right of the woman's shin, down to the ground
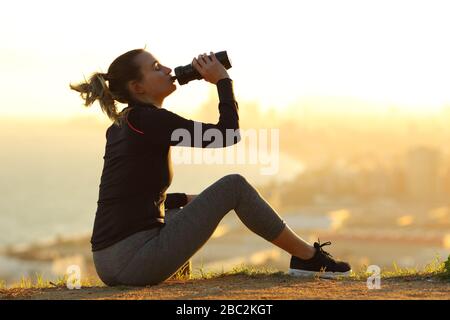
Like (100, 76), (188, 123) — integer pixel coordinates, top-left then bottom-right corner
(255, 146), (450, 269)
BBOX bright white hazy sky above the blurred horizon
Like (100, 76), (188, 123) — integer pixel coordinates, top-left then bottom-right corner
(0, 0), (450, 117)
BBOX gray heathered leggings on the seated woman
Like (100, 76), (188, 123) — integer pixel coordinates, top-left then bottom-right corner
(93, 174), (286, 286)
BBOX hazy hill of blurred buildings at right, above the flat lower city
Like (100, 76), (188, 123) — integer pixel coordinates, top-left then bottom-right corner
(262, 146), (450, 207)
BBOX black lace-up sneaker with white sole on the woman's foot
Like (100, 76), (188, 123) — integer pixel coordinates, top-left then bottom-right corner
(289, 240), (352, 278)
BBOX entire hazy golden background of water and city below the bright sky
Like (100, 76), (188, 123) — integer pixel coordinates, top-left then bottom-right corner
(0, 99), (450, 283)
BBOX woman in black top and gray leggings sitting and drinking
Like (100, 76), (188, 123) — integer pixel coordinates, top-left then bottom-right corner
(70, 49), (350, 286)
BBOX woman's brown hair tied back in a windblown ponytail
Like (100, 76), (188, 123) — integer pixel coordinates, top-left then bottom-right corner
(70, 49), (145, 126)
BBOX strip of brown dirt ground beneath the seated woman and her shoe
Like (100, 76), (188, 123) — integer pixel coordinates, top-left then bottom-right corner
(0, 275), (450, 300)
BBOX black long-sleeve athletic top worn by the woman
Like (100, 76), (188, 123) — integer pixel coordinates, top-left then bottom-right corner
(91, 78), (240, 251)
